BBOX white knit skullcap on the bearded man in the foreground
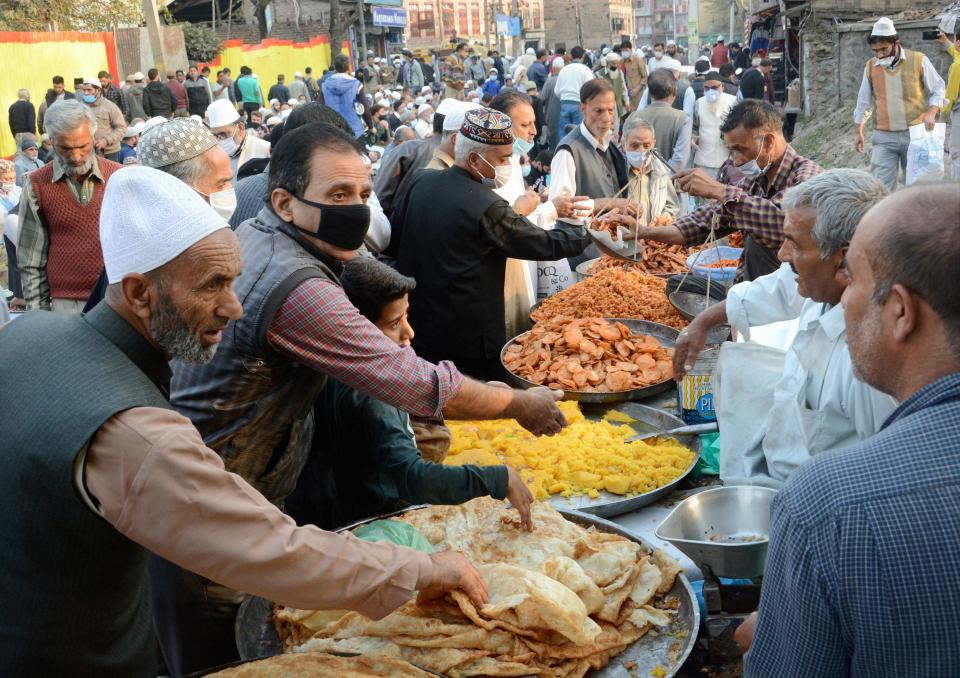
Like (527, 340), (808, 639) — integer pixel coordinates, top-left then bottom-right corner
(100, 165), (229, 284)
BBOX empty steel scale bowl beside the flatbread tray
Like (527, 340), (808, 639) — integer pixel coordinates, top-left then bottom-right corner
(655, 485), (777, 578)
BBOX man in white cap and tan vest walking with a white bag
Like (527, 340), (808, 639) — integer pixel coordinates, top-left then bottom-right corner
(853, 17), (947, 191)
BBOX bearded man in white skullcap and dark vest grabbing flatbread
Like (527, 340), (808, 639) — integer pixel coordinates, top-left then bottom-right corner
(0, 166), (488, 678)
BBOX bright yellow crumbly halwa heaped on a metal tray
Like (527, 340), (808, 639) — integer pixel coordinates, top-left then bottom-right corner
(444, 400), (695, 499)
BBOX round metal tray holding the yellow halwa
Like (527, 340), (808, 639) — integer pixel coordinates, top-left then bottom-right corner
(550, 403), (702, 518)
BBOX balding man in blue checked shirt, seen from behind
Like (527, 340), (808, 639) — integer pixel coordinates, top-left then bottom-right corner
(738, 184), (960, 678)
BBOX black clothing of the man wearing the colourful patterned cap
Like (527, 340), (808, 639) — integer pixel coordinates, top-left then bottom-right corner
(390, 165), (590, 370)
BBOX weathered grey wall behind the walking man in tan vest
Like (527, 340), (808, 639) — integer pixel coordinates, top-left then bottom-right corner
(803, 17), (950, 114)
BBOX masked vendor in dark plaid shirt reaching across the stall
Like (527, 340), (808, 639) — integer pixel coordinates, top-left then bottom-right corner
(623, 99), (823, 280)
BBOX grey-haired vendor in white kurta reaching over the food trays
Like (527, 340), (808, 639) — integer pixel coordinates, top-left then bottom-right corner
(674, 169), (896, 488)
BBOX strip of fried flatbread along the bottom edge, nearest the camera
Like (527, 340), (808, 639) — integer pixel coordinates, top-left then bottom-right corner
(209, 652), (432, 678)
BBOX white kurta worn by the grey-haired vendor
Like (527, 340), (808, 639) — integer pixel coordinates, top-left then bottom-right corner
(714, 264), (896, 487)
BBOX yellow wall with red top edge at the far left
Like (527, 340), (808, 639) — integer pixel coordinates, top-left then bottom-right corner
(0, 31), (119, 157)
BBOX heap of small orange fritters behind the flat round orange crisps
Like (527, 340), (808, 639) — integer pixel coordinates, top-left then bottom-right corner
(531, 269), (688, 330)
